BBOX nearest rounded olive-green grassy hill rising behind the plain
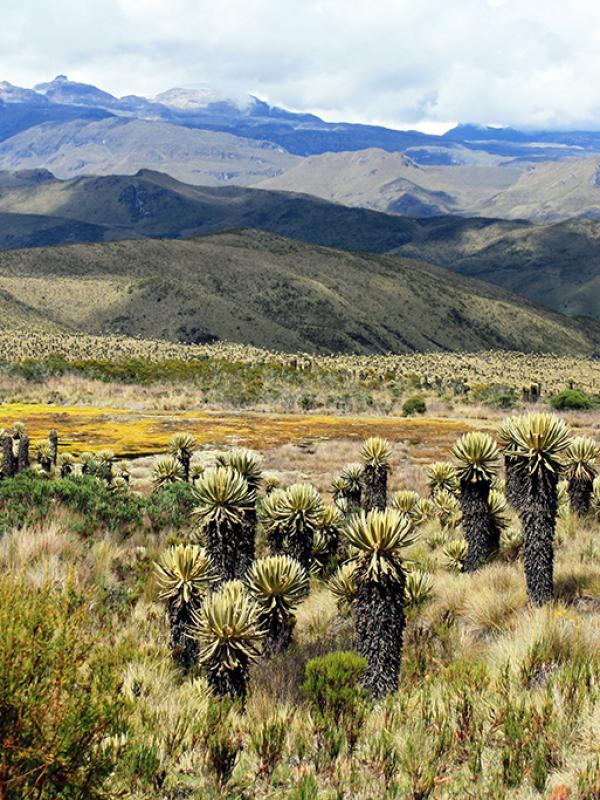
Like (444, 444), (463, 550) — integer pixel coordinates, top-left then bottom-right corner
(0, 231), (600, 353)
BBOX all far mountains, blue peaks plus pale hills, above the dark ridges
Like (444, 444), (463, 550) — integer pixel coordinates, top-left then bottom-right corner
(0, 76), (600, 221)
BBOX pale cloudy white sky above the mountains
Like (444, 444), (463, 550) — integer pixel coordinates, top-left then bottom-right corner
(0, 0), (600, 132)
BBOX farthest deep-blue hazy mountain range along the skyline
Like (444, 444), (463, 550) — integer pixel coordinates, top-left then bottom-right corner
(5, 76), (600, 165)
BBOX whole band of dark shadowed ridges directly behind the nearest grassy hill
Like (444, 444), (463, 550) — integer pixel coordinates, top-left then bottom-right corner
(0, 170), (600, 319)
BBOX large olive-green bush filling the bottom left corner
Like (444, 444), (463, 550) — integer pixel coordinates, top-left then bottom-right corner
(0, 576), (125, 800)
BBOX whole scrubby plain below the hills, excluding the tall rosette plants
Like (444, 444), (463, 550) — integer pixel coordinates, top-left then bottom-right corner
(0, 337), (600, 800)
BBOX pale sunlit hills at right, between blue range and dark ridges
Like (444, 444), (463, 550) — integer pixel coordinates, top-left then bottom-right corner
(260, 146), (600, 222)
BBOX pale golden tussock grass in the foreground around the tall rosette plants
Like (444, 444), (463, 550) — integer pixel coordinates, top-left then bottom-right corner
(0, 472), (600, 800)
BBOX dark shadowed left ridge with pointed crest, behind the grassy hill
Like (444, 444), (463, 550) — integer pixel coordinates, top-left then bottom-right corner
(0, 170), (419, 252)
